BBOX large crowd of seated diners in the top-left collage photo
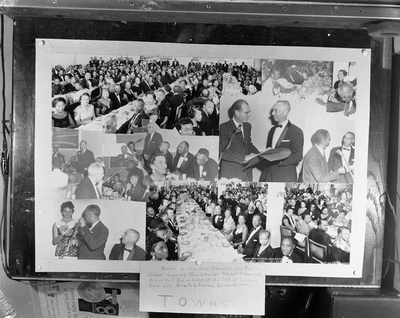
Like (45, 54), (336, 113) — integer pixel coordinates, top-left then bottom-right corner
(52, 57), (261, 136)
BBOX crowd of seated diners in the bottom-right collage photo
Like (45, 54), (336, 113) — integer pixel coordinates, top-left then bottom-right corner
(281, 188), (353, 263)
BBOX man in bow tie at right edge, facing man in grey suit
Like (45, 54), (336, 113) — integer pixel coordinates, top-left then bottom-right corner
(328, 131), (355, 183)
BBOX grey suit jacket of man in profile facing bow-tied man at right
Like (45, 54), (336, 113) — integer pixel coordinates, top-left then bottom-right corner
(303, 145), (339, 183)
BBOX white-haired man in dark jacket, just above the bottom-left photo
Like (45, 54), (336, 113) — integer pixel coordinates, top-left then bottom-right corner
(75, 163), (104, 199)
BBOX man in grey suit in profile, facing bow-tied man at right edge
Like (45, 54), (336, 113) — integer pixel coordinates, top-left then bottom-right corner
(303, 129), (346, 183)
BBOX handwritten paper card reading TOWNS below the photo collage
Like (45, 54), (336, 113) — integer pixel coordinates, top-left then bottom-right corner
(140, 262), (265, 315)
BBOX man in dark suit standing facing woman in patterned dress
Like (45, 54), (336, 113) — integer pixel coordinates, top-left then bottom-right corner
(77, 204), (109, 260)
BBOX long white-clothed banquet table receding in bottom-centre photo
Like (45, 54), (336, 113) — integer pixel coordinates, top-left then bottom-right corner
(176, 195), (244, 263)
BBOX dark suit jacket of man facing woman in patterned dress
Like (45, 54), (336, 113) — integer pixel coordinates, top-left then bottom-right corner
(78, 221), (108, 260)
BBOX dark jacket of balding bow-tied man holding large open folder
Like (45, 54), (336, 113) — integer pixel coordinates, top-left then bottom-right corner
(260, 121), (304, 182)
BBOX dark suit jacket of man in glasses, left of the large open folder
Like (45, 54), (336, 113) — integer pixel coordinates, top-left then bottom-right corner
(219, 119), (259, 181)
